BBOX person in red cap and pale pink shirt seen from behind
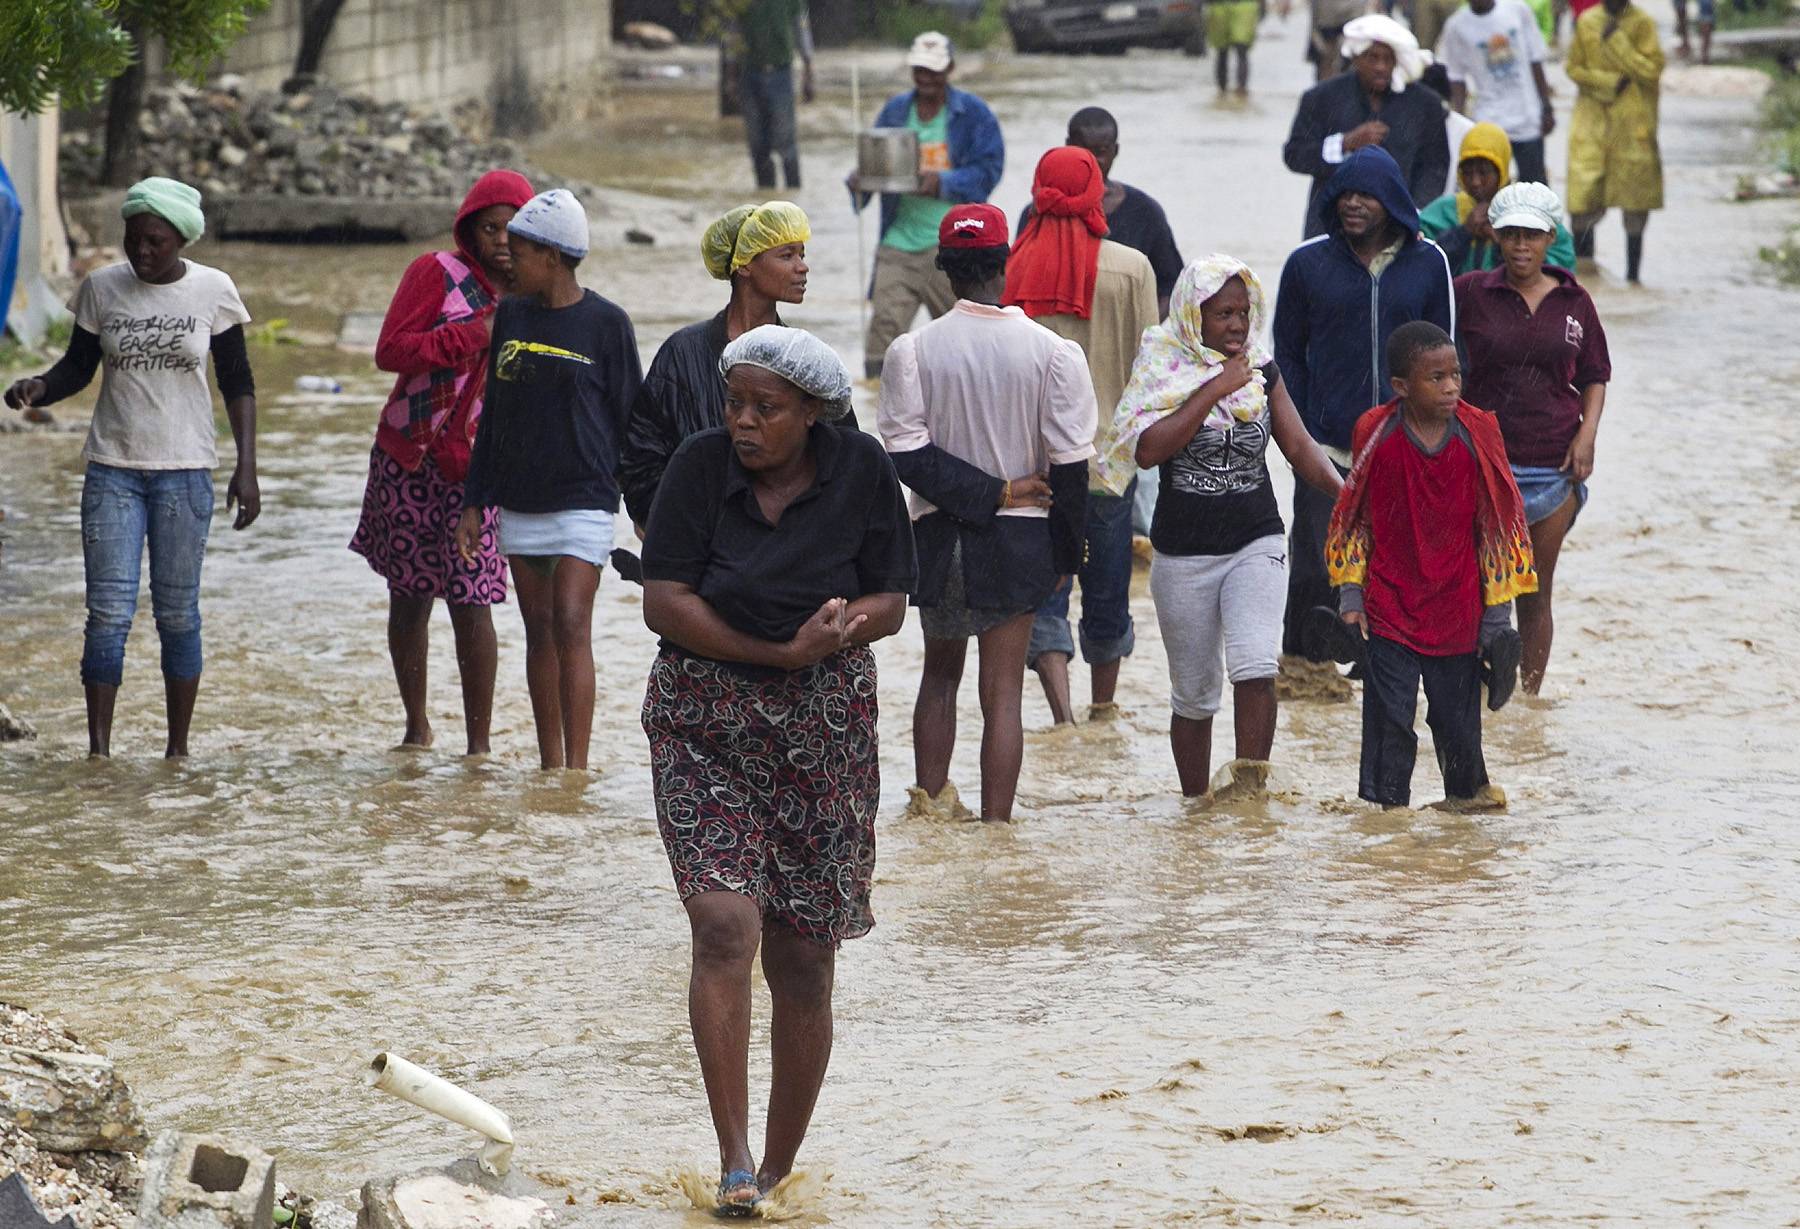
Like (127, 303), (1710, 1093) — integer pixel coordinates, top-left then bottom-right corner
(878, 205), (1098, 821)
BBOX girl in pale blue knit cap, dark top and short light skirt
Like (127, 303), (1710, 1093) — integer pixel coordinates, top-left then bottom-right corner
(455, 189), (643, 768)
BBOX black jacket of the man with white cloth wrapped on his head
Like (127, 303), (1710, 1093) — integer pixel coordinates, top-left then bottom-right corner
(1282, 72), (1451, 239)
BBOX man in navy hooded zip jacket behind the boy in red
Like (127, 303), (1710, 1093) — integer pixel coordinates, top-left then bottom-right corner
(1274, 146), (1456, 669)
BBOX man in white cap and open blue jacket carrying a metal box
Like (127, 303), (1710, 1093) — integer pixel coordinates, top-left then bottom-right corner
(850, 31), (1006, 376)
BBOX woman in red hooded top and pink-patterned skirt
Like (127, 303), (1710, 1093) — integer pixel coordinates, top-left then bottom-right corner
(349, 171), (531, 756)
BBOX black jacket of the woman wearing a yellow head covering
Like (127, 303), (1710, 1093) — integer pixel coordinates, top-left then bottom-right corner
(619, 311), (859, 525)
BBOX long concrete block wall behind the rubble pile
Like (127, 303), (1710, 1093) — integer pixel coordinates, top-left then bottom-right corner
(220, 0), (612, 128)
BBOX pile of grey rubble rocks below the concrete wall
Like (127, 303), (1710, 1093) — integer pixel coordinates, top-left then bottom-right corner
(61, 76), (569, 200)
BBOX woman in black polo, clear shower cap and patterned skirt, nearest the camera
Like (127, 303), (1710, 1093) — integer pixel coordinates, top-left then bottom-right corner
(643, 324), (916, 1215)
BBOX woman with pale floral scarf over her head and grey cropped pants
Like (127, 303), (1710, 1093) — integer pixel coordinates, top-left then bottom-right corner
(1109, 256), (1341, 795)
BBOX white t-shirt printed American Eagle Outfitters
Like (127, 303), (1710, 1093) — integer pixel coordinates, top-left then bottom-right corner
(70, 261), (250, 470)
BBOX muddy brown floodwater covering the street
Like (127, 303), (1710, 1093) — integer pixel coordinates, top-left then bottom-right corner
(0, 11), (1800, 1227)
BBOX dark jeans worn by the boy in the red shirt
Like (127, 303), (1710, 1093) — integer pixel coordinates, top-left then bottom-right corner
(1357, 635), (1487, 806)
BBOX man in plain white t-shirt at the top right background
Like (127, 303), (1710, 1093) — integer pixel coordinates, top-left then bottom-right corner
(1438, 0), (1557, 184)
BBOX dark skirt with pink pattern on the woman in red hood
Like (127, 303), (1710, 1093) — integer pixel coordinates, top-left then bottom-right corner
(349, 444), (506, 606)
